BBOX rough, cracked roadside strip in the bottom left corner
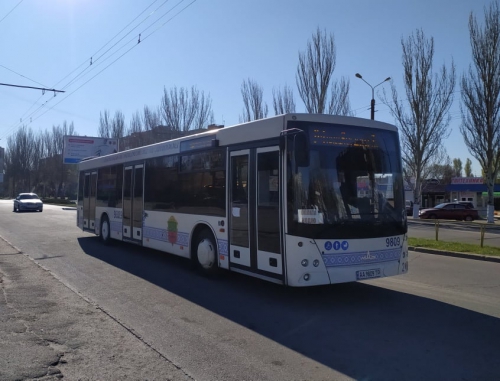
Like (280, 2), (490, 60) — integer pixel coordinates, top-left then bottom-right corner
(0, 237), (192, 381)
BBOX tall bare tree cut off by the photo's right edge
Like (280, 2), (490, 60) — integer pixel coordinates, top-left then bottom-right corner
(460, 2), (500, 223)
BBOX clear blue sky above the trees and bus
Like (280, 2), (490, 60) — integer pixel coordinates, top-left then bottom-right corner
(0, 0), (490, 176)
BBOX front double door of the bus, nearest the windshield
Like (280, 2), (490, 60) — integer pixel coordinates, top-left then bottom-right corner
(229, 146), (284, 283)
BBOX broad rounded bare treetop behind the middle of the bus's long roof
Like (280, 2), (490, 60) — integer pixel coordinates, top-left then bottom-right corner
(160, 86), (213, 131)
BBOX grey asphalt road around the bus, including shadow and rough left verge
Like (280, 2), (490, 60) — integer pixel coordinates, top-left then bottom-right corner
(0, 201), (500, 380)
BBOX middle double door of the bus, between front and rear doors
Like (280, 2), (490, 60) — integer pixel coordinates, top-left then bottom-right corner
(122, 164), (144, 242)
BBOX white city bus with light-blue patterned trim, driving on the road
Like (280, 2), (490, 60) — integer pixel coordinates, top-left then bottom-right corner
(77, 114), (408, 287)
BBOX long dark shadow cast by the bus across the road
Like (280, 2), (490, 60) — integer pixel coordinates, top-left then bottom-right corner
(79, 237), (500, 380)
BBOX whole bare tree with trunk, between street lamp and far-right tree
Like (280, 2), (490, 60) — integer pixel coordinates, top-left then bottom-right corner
(383, 30), (455, 218)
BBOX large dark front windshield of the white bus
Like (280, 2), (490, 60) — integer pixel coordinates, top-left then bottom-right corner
(287, 122), (406, 238)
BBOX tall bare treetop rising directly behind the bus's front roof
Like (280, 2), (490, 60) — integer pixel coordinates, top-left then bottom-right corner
(295, 28), (351, 115)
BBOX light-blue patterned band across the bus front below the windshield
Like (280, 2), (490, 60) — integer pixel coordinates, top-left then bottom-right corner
(323, 248), (401, 267)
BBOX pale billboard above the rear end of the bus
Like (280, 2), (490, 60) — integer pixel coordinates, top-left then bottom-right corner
(63, 135), (118, 164)
